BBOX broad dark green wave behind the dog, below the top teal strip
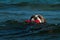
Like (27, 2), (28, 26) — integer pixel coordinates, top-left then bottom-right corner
(0, 2), (60, 10)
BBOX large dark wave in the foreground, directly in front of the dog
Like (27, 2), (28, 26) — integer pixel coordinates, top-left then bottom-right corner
(0, 20), (60, 38)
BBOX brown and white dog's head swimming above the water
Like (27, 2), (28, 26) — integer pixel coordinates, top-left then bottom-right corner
(30, 14), (46, 23)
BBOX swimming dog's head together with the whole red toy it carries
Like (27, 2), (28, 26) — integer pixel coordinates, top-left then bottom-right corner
(25, 15), (46, 24)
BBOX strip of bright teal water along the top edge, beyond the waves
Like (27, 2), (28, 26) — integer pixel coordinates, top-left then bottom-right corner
(0, 0), (60, 4)
